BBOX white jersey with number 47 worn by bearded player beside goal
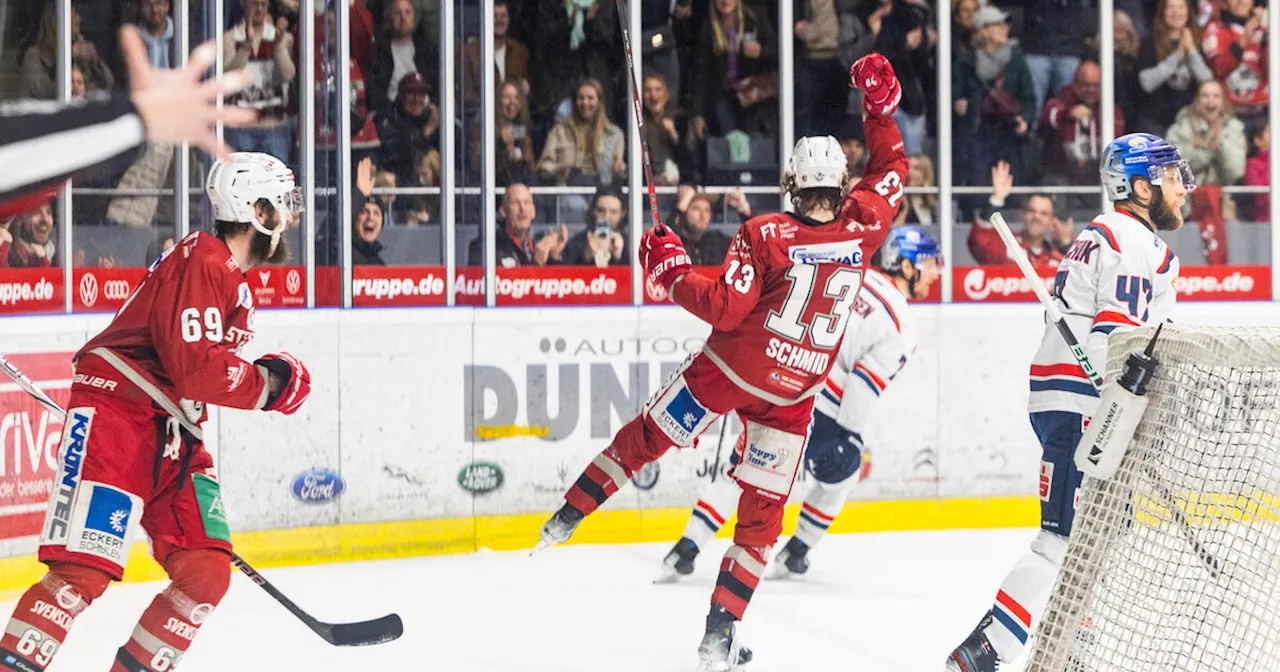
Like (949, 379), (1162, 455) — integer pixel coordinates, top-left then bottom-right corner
(1028, 210), (1179, 417)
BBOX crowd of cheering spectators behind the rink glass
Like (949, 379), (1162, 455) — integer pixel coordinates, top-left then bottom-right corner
(0, 0), (1270, 273)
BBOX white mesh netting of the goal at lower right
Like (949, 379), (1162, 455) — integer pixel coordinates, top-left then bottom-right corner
(1027, 325), (1280, 672)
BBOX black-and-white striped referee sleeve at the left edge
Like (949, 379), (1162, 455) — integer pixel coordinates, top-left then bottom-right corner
(0, 92), (145, 201)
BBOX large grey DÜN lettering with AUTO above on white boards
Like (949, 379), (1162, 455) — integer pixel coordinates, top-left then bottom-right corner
(462, 335), (703, 442)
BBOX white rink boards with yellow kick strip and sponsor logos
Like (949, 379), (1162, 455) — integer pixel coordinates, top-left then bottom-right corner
(0, 303), (1280, 591)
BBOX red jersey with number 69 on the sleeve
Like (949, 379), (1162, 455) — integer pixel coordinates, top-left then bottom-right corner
(76, 232), (268, 422)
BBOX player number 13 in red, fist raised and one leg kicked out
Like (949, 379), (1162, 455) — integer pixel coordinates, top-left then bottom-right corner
(539, 54), (908, 671)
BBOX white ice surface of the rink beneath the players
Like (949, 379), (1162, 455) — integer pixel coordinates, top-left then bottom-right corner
(0, 529), (1034, 672)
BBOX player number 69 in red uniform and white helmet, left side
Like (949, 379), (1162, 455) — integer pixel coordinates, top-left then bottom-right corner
(0, 154), (311, 672)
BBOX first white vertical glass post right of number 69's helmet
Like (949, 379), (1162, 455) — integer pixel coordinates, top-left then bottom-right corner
(294, 0), (316, 308)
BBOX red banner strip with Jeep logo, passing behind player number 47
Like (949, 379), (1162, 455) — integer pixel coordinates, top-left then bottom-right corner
(951, 266), (1271, 303)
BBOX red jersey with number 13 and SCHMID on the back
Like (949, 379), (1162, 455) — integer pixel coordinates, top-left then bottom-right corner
(671, 116), (908, 404)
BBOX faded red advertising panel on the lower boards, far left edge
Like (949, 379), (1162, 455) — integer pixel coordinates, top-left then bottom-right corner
(0, 352), (74, 539)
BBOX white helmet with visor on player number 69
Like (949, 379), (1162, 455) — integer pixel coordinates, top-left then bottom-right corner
(205, 152), (302, 253)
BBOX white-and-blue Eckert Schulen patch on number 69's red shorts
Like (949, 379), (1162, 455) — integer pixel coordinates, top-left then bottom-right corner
(67, 481), (142, 567)
